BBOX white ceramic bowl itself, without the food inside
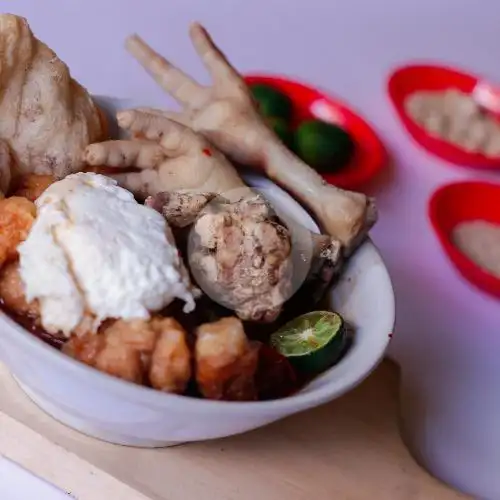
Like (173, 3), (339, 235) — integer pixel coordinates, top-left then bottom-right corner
(0, 99), (394, 447)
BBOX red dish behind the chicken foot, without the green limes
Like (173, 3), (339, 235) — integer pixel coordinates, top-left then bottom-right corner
(245, 75), (387, 189)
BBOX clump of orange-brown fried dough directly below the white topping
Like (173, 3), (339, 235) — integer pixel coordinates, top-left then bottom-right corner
(63, 318), (191, 394)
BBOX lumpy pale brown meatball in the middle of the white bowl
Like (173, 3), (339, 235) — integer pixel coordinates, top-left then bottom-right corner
(188, 193), (293, 323)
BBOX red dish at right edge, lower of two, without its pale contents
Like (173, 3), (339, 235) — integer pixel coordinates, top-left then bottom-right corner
(429, 181), (500, 298)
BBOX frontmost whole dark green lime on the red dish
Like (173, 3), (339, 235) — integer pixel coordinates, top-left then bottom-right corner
(295, 120), (356, 173)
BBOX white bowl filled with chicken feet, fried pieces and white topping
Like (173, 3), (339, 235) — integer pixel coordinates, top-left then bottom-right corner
(0, 15), (394, 447)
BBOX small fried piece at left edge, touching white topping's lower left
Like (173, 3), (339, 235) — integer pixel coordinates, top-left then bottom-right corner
(0, 261), (40, 322)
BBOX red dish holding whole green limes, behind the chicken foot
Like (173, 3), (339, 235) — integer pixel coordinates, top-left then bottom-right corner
(245, 74), (387, 189)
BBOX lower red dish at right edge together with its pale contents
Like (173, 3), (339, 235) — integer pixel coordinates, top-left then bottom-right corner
(429, 181), (500, 297)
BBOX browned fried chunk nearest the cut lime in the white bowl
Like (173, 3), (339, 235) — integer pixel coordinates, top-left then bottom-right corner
(195, 317), (259, 401)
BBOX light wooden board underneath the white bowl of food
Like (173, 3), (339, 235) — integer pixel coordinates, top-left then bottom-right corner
(0, 362), (468, 500)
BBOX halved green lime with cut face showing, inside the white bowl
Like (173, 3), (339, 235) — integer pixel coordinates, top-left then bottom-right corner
(271, 311), (347, 373)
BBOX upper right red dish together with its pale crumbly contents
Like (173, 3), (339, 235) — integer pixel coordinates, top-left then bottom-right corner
(388, 64), (500, 168)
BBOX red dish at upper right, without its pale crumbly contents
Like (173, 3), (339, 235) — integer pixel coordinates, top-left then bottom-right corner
(388, 64), (500, 169)
